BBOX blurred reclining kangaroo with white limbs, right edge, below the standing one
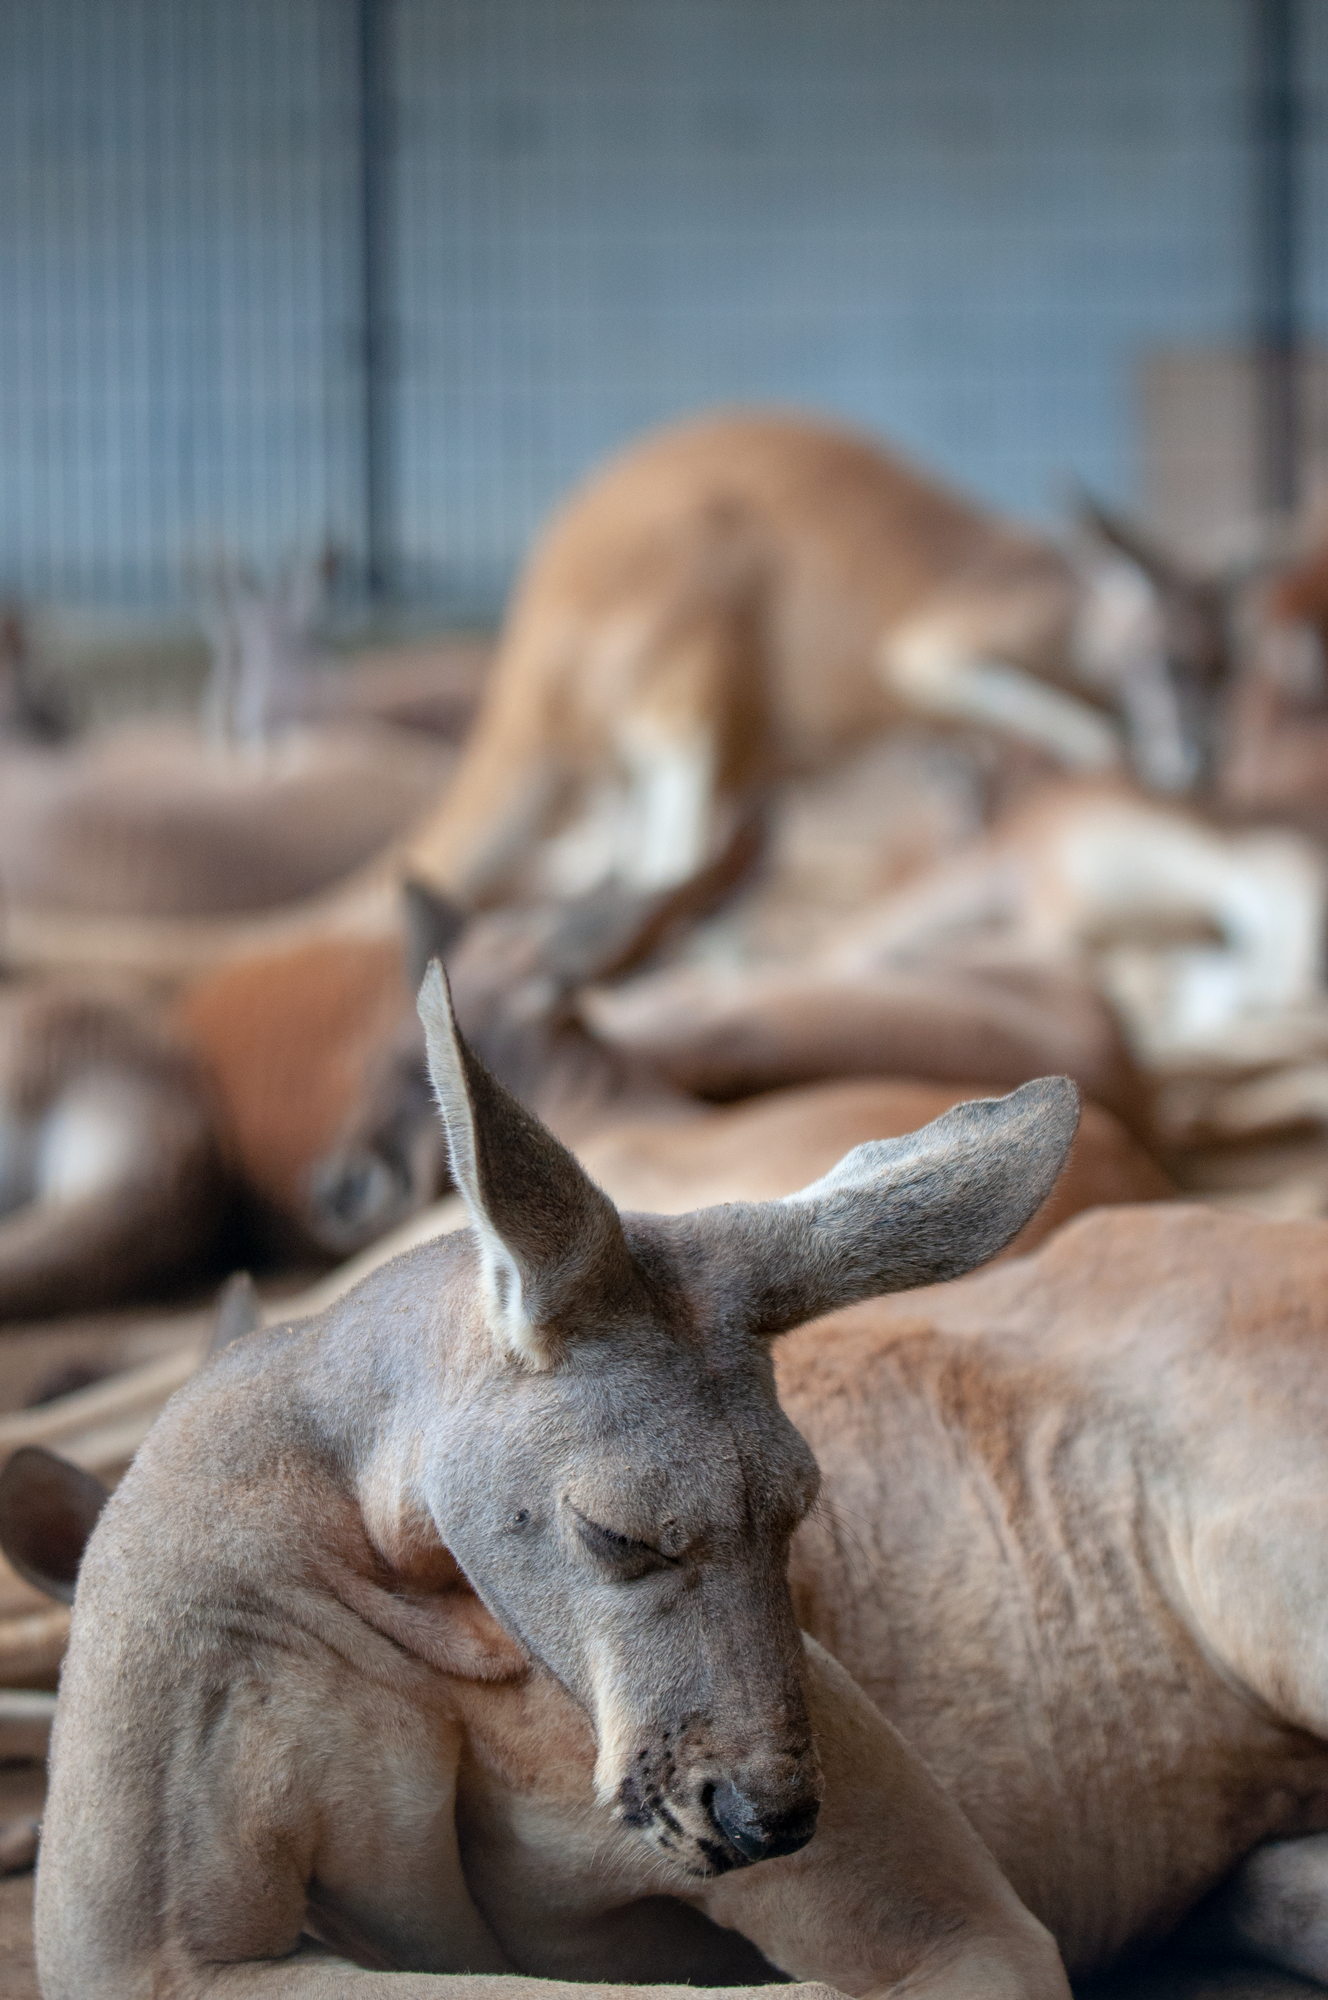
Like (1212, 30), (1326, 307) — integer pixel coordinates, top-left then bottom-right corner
(788, 780), (1328, 1070)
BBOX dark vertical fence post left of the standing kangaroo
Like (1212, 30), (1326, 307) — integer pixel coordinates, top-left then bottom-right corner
(356, 0), (396, 604)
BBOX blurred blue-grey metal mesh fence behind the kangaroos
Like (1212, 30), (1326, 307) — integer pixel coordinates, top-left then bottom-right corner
(0, 0), (1328, 618)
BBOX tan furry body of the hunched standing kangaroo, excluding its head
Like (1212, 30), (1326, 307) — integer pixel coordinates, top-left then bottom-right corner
(410, 414), (1112, 898)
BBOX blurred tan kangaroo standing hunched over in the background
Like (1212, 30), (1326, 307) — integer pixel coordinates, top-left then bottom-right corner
(408, 412), (1226, 902)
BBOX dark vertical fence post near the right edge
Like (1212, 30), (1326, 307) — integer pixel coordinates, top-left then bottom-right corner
(1252, 0), (1302, 514)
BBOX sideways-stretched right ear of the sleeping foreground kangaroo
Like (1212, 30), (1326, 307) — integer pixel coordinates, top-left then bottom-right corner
(680, 1076), (1078, 1334)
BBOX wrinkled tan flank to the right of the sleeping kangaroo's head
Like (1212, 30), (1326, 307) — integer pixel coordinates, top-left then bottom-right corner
(778, 1206), (1328, 1982)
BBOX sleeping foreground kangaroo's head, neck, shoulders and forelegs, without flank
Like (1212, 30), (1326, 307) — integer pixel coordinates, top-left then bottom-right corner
(36, 968), (1076, 2000)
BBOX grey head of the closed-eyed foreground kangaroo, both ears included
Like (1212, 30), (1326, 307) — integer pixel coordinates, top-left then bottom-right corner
(420, 966), (1078, 1876)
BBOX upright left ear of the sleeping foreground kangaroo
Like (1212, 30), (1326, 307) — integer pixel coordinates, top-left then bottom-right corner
(418, 960), (636, 1368)
